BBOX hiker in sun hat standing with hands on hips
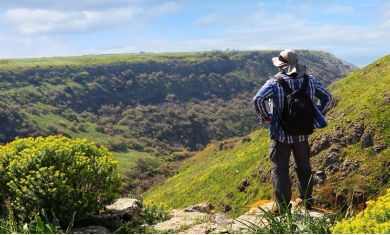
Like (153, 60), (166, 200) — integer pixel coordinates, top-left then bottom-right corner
(253, 50), (333, 213)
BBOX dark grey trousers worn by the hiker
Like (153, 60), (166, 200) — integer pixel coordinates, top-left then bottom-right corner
(269, 140), (313, 205)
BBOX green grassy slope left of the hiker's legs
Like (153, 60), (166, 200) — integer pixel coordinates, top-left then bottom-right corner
(143, 130), (270, 218)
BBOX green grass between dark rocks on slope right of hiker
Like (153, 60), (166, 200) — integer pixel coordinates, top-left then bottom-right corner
(311, 56), (390, 198)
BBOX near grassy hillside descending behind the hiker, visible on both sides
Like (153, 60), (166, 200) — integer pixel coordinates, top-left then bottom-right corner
(143, 56), (390, 214)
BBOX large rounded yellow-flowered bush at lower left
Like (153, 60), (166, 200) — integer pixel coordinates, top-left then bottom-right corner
(0, 136), (121, 221)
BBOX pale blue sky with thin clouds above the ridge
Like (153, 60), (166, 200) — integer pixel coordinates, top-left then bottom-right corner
(0, 0), (390, 67)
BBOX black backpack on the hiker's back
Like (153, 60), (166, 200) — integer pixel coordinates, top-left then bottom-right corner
(275, 74), (314, 136)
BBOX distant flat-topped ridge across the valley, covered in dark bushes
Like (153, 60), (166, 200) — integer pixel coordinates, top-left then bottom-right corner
(0, 50), (357, 151)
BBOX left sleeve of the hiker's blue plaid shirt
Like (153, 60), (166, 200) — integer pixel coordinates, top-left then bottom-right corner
(253, 80), (273, 121)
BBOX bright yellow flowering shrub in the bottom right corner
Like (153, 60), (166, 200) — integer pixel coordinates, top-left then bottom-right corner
(332, 189), (390, 234)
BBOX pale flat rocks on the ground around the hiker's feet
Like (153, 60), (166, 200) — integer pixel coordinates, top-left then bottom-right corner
(71, 199), (328, 234)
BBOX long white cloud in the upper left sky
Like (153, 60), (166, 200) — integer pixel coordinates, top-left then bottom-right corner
(0, 0), (182, 35)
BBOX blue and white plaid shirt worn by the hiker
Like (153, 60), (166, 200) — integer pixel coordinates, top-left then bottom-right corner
(253, 71), (333, 144)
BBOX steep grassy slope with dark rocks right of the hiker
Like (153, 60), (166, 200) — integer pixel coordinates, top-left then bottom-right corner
(312, 53), (390, 204)
